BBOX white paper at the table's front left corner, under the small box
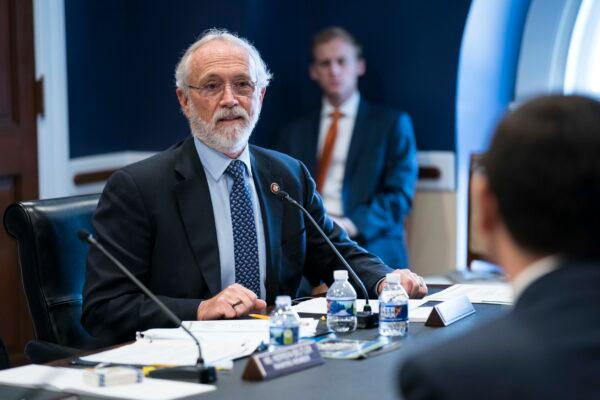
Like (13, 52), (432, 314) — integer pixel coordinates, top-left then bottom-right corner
(0, 365), (216, 400)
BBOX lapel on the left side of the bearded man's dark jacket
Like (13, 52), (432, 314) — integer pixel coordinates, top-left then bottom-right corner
(175, 137), (221, 296)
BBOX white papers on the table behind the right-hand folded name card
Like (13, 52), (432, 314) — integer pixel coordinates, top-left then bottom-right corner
(425, 283), (513, 304)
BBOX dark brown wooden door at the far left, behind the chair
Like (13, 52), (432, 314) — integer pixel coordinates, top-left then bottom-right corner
(0, 0), (38, 365)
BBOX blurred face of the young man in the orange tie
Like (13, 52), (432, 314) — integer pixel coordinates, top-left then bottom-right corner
(310, 38), (365, 105)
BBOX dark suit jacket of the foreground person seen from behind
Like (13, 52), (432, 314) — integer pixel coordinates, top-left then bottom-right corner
(400, 261), (600, 400)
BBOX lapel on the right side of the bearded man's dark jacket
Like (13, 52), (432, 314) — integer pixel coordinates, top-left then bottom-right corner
(250, 147), (283, 304)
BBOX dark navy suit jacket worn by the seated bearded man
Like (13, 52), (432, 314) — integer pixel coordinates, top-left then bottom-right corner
(82, 137), (391, 342)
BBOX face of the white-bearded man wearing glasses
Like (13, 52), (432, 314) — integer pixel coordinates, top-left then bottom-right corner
(177, 40), (265, 157)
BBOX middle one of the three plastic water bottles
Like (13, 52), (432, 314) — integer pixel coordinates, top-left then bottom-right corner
(327, 270), (356, 333)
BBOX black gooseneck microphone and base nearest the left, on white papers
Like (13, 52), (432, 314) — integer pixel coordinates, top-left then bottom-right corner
(77, 229), (217, 383)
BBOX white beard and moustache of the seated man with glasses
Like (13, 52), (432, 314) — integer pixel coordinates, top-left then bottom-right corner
(188, 102), (260, 154)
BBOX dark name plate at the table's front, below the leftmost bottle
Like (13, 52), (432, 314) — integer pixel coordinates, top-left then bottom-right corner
(242, 343), (325, 381)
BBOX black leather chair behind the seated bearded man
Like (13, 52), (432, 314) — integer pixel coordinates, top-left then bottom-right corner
(4, 194), (103, 363)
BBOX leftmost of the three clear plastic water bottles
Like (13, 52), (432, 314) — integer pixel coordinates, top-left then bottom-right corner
(269, 296), (300, 347)
